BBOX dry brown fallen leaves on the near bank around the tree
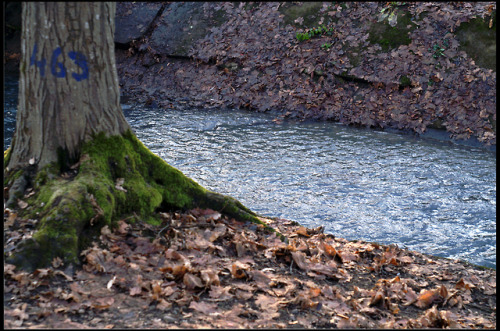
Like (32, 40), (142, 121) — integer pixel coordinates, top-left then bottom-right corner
(4, 209), (496, 328)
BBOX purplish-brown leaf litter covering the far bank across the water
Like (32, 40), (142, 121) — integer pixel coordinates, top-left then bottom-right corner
(117, 2), (496, 145)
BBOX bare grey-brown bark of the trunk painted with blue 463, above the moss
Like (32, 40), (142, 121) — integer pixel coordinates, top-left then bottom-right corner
(8, 2), (129, 169)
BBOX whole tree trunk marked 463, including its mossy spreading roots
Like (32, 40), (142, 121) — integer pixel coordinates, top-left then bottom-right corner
(4, 2), (282, 270)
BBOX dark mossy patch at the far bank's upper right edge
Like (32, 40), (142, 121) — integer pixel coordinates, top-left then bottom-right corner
(455, 11), (497, 72)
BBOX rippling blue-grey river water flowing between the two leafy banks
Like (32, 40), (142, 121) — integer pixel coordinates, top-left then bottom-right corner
(4, 81), (496, 268)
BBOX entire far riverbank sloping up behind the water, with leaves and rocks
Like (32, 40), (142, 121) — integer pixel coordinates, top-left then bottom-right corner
(4, 2), (496, 148)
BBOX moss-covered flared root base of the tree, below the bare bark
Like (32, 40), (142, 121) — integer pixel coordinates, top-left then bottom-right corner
(7, 131), (283, 270)
